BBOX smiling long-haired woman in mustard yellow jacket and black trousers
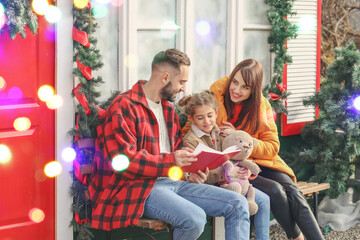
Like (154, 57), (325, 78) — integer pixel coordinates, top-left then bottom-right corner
(183, 59), (324, 240)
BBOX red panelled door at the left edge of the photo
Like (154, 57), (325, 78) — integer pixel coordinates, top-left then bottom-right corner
(0, 15), (55, 240)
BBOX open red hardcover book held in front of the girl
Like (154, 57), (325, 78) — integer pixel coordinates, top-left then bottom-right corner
(181, 143), (241, 173)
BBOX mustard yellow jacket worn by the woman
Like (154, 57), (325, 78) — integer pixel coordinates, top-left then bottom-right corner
(183, 77), (296, 182)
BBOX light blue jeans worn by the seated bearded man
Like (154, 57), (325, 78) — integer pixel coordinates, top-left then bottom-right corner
(143, 178), (250, 240)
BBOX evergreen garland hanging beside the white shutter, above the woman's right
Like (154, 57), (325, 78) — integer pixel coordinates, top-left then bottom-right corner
(263, 0), (297, 113)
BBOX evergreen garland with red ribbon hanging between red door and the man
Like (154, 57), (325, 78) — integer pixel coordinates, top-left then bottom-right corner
(69, 4), (103, 240)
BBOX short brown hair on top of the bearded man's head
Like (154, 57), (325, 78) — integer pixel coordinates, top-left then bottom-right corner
(151, 48), (190, 70)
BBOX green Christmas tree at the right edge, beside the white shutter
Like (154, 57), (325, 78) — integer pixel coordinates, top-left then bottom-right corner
(298, 43), (360, 198)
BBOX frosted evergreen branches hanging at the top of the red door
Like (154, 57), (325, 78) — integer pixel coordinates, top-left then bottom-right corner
(0, 0), (38, 39)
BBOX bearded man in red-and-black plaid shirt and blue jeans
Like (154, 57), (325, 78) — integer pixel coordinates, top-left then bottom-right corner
(89, 49), (249, 240)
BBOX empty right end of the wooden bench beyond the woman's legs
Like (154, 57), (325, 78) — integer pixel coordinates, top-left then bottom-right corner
(296, 182), (330, 220)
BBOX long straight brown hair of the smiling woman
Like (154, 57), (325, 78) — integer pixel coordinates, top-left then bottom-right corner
(224, 59), (263, 134)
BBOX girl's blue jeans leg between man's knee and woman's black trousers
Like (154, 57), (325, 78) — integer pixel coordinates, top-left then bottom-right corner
(254, 188), (270, 240)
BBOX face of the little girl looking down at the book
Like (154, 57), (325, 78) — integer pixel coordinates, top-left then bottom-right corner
(189, 105), (217, 134)
